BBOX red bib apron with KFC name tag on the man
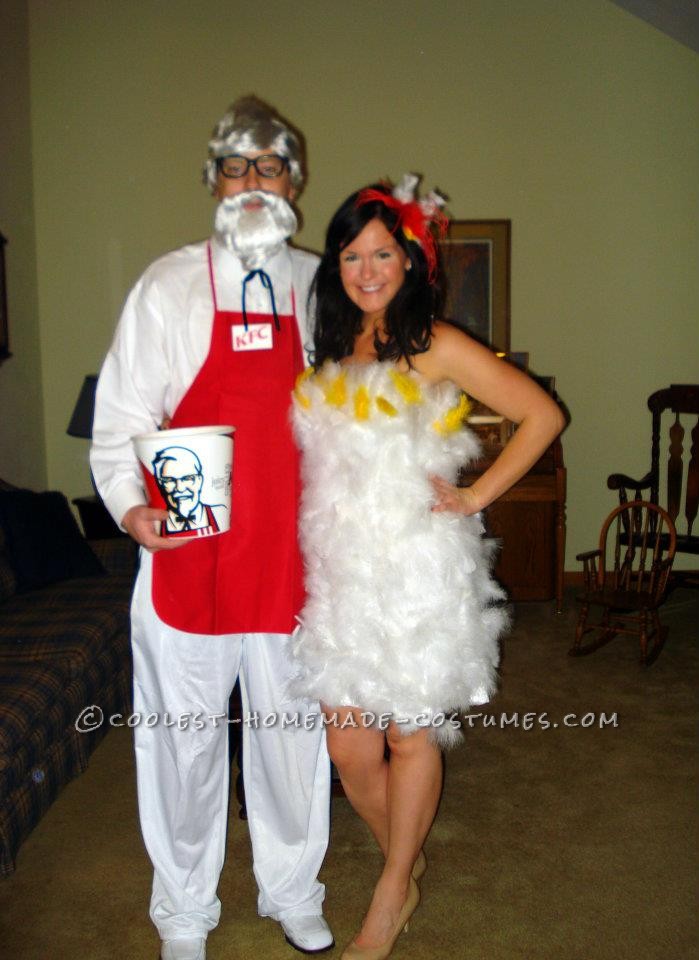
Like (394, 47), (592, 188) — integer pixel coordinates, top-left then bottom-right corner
(152, 248), (303, 635)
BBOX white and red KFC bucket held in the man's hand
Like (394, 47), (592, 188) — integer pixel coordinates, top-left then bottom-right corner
(133, 426), (235, 539)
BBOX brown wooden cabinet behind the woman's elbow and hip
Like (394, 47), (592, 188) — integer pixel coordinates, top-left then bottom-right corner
(460, 439), (566, 612)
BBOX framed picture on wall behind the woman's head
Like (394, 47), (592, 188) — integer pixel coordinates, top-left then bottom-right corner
(439, 220), (511, 353)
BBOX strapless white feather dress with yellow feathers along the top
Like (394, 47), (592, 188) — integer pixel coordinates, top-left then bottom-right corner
(292, 361), (507, 746)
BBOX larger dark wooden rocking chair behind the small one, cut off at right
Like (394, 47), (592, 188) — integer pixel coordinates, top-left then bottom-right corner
(607, 384), (699, 586)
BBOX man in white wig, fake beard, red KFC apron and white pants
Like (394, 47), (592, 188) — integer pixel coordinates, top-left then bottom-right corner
(91, 97), (333, 960)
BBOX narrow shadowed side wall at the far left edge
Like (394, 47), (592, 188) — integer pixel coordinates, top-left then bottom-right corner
(0, 0), (46, 489)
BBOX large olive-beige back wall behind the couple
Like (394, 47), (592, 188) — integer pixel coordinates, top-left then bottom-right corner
(23, 0), (699, 568)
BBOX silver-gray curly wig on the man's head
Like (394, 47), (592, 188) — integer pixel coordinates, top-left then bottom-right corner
(203, 95), (304, 193)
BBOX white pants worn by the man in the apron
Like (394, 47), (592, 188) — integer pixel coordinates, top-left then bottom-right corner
(131, 547), (330, 940)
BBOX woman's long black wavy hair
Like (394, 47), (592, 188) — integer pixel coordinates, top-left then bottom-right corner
(310, 184), (438, 369)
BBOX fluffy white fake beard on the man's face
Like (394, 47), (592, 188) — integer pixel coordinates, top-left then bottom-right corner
(214, 190), (298, 270)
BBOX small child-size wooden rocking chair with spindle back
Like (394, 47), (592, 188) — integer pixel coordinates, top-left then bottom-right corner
(568, 500), (677, 666)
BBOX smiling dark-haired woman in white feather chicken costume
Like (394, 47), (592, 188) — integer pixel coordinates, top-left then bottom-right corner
(294, 177), (563, 960)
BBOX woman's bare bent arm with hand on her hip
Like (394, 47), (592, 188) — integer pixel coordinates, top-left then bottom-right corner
(413, 323), (565, 514)
